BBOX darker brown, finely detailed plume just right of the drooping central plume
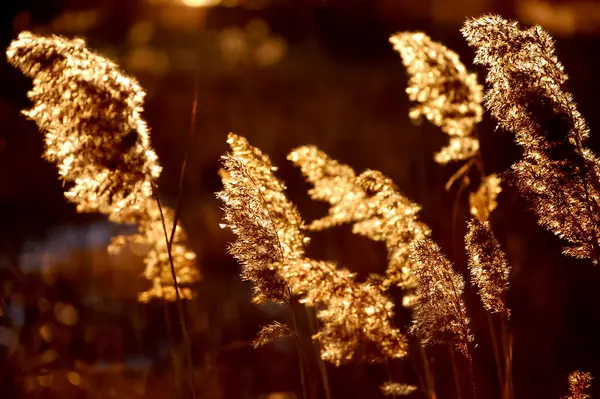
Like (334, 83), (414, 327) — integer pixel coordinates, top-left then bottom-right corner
(410, 239), (473, 359)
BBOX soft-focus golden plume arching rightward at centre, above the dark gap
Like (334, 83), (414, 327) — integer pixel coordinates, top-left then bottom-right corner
(288, 146), (430, 288)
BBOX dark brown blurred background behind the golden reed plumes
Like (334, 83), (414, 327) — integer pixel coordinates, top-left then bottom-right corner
(0, 0), (600, 399)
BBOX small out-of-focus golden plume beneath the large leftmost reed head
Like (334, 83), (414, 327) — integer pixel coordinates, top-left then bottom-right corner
(108, 199), (200, 302)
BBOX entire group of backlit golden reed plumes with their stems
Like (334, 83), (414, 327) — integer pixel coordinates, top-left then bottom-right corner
(7, 15), (600, 399)
